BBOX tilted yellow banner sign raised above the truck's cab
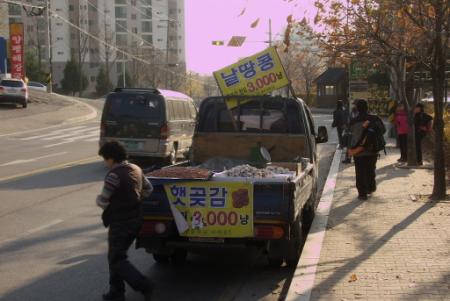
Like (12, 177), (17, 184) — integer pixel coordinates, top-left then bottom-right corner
(214, 47), (289, 95)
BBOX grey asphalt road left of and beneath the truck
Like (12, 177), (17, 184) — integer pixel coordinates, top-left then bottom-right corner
(0, 109), (336, 301)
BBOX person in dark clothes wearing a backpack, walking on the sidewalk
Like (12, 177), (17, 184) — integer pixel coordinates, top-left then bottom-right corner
(349, 99), (386, 200)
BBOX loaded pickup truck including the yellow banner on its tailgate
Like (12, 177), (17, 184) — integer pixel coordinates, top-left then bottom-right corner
(136, 96), (328, 266)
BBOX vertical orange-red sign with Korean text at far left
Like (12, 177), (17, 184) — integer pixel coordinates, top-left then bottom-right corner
(9, 23), (25, 78)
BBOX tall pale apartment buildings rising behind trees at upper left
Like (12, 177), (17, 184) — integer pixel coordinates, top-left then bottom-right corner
(5, 0), (186, 95)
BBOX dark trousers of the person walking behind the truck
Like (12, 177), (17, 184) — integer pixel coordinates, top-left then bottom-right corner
(108, 219), (147, 292)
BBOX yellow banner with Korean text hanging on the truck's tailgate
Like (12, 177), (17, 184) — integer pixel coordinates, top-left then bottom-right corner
(164, 182), (253, 238)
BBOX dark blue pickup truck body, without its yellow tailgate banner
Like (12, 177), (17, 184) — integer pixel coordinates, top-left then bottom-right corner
(136, 96), (328, 266)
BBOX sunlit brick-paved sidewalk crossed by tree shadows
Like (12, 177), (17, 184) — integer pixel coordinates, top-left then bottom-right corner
(297, 148), (450, 301)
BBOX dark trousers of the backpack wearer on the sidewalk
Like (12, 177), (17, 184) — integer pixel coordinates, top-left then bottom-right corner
(354, 155), (378, 195)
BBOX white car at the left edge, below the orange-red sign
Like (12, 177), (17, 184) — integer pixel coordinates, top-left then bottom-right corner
(0, 79), (28, 108)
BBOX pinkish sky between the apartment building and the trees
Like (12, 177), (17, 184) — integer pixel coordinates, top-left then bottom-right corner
(185, 0), (315, 75)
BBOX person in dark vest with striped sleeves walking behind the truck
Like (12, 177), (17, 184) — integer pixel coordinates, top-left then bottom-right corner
(97, 141), (153, 301)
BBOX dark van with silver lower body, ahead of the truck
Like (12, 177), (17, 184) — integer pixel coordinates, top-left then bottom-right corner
(100, 88), (197, 164)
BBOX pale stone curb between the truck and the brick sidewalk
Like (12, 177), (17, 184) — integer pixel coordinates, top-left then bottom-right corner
(285, 149), (342, 301)
